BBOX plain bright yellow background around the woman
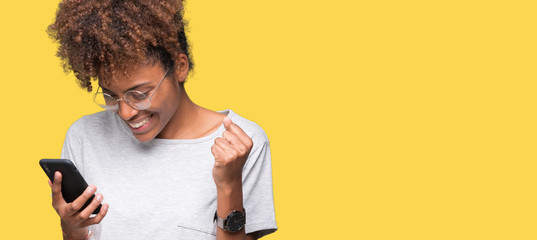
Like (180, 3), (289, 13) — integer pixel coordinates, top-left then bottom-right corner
(0, 0), (537, 240)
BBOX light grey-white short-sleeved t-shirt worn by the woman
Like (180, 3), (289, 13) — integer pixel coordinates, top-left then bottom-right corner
(61, 110), (277, 240)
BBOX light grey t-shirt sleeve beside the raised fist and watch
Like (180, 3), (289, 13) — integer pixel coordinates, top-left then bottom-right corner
(243, 132), (278, 237)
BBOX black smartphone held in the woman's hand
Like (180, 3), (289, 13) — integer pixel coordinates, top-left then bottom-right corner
(39, 159), (102, 214)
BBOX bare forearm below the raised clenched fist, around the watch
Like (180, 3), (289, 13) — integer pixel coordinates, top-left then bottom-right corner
(216, 182), (246, 240)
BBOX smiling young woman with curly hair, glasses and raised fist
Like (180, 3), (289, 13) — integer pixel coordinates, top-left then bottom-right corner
(48, 0), (277, 240)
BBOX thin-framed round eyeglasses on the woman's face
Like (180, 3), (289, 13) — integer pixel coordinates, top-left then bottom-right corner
(93, 68), (170, 111)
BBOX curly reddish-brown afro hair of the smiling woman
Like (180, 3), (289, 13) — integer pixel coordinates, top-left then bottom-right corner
(47, 0), (193, 91)
